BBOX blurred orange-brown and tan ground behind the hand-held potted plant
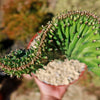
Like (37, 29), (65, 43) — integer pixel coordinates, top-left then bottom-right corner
(0, 0), (100, 100)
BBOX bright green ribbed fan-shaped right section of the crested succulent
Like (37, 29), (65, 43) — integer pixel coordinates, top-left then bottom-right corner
(37, 11), (100, 75)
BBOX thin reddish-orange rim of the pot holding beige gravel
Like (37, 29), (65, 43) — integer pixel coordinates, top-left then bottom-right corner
(27, 31), (87, 87)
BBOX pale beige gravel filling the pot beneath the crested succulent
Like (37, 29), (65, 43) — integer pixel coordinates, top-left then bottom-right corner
(35, 59), (85, 86)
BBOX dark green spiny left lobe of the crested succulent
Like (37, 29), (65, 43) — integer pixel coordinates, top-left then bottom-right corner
(0, 48), (42, 77)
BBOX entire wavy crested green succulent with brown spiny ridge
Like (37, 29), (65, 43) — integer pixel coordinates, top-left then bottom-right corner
(0, 11), (100, 76)
